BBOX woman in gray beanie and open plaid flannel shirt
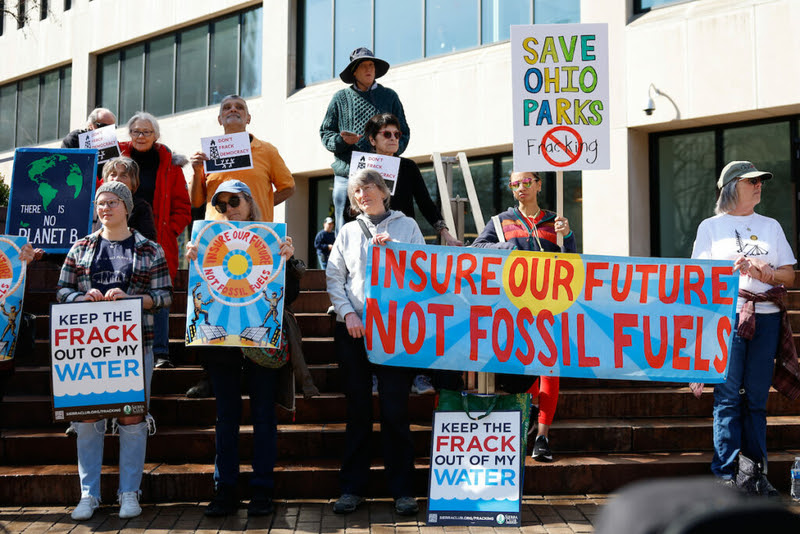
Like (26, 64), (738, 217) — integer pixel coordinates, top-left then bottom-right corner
(57, 182), (172, 520)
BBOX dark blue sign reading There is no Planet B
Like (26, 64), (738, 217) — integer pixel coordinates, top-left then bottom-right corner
(6, 148), (97, 252)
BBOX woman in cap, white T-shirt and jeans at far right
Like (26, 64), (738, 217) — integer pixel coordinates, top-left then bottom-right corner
(690, 161), (797, 496)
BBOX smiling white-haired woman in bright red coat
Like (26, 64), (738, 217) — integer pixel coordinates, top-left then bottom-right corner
(119, 111), (192, 367)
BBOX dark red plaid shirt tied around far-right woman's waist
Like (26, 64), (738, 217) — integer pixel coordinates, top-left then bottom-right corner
(736, 286), (800, 400)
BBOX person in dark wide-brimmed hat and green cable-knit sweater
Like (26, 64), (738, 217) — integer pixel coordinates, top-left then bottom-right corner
(319, 48), (411, 233)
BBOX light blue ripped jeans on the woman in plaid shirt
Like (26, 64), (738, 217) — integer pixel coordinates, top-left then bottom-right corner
(72, 349), (153, 500)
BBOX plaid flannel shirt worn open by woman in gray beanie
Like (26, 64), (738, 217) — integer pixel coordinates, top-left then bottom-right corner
(56, 230), (172, 350)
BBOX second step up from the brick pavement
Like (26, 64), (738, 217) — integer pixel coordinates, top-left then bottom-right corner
(0, 413), (800, 465)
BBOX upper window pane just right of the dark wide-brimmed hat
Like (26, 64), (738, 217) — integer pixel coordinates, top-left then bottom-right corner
(374, 0), (423, 65)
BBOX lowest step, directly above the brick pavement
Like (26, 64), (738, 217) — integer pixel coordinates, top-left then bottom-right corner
(6, 449), (800, 506)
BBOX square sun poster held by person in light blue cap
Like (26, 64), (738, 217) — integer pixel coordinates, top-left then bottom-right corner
(186, 221), (286, 348)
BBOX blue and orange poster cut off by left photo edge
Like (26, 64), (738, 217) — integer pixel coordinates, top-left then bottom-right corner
(0, 235), (28, 369)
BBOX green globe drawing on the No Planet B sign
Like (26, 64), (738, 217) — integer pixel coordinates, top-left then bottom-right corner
(27, 154), (83, 212)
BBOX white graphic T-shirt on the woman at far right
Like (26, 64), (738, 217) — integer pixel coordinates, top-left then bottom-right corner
(692, 213), (797, 313)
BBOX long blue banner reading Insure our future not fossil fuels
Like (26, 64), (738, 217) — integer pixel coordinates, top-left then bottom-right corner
(363, 243), (739, 384)
